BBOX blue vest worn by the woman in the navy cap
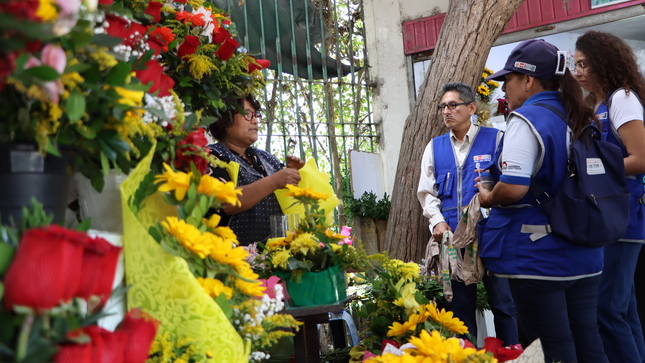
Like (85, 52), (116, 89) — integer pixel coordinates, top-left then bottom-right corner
(479, 92), (603, 280)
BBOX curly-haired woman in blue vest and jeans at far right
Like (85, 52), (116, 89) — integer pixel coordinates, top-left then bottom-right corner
(574, 31), (645, 363)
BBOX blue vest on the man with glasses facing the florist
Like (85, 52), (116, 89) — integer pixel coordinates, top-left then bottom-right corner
(432, 127), (500, 231)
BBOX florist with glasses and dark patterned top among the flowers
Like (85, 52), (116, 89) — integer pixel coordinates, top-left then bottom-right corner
(208, 96), (304, 246)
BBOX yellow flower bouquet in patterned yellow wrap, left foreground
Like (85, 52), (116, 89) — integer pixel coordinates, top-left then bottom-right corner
(125, 154), (299, 362)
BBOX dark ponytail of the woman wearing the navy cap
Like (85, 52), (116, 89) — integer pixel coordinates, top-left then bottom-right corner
(538, 69), (600, 141)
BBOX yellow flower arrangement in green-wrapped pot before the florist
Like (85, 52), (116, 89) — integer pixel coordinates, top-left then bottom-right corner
(255, 185), (364, 306)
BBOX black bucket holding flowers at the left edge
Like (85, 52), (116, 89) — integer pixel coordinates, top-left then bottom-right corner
(0, 144), (73, 226)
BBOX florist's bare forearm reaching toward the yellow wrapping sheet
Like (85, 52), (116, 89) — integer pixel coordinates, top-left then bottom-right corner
(224, 168), (300, 215)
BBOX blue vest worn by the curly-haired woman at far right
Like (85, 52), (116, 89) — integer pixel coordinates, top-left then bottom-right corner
(596, 93), (645, 242)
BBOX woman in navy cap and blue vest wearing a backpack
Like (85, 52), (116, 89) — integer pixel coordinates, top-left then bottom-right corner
(477, 39), (608, 363)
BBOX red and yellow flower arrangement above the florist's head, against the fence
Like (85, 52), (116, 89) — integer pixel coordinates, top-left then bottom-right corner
(117, 0), (269, 120)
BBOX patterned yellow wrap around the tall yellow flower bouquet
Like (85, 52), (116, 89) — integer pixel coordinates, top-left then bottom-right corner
(121, 144), (250, 363)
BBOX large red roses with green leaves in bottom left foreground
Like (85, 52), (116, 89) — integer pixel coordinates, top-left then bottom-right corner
(0, 202), (158, 363)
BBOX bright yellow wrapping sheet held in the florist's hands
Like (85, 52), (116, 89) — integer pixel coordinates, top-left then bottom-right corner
(275, 158), (338, 223)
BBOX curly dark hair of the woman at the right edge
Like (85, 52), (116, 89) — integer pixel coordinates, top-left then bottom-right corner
(576, 31), (645, 105)
